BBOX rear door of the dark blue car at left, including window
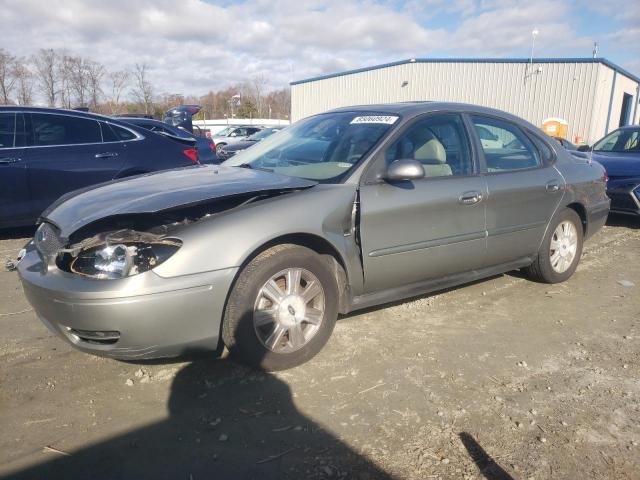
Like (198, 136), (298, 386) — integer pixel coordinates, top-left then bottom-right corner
(26, 112), (125, 217)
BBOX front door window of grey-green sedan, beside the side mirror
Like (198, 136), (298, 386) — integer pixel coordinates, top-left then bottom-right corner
(385, 114), (473, 177)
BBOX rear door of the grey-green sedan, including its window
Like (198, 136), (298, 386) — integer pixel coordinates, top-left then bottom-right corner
(470, 115), (565, 266)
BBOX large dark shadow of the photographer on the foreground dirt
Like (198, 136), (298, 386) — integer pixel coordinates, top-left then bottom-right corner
(5, 360), (393, 480)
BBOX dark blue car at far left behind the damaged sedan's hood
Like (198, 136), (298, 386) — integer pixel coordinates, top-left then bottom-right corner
(0, 106), (198, 228)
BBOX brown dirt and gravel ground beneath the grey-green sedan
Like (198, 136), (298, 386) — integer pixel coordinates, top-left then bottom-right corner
(0, 218), (640, 480)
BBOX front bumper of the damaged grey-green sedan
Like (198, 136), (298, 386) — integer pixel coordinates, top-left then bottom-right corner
(18, 249), (237, 360)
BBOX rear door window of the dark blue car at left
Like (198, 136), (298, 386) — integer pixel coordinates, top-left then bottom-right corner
(31, 113), (102, 146)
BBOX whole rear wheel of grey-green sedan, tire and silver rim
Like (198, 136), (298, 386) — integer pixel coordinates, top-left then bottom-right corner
(525, 208), (583, 283)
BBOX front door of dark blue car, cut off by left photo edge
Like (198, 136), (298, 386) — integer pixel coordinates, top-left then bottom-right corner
(0, 112), (31, 227)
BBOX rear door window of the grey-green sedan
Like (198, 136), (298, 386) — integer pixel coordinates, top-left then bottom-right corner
(471, 115), (542, 173)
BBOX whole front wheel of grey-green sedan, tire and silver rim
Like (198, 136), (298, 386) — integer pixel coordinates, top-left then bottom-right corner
(222, 245), (338, 370)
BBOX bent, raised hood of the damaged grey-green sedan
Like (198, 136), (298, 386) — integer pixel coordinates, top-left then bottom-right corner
(41, 165), (317, 238)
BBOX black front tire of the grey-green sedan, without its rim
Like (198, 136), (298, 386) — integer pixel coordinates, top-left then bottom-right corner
(222, 244), (339, 371)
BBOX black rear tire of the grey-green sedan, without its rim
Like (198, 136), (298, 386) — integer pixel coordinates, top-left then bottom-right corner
(524, 208), (583, 283)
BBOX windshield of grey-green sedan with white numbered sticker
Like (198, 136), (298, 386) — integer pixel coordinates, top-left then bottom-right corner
(224, 112), (398, 181)
